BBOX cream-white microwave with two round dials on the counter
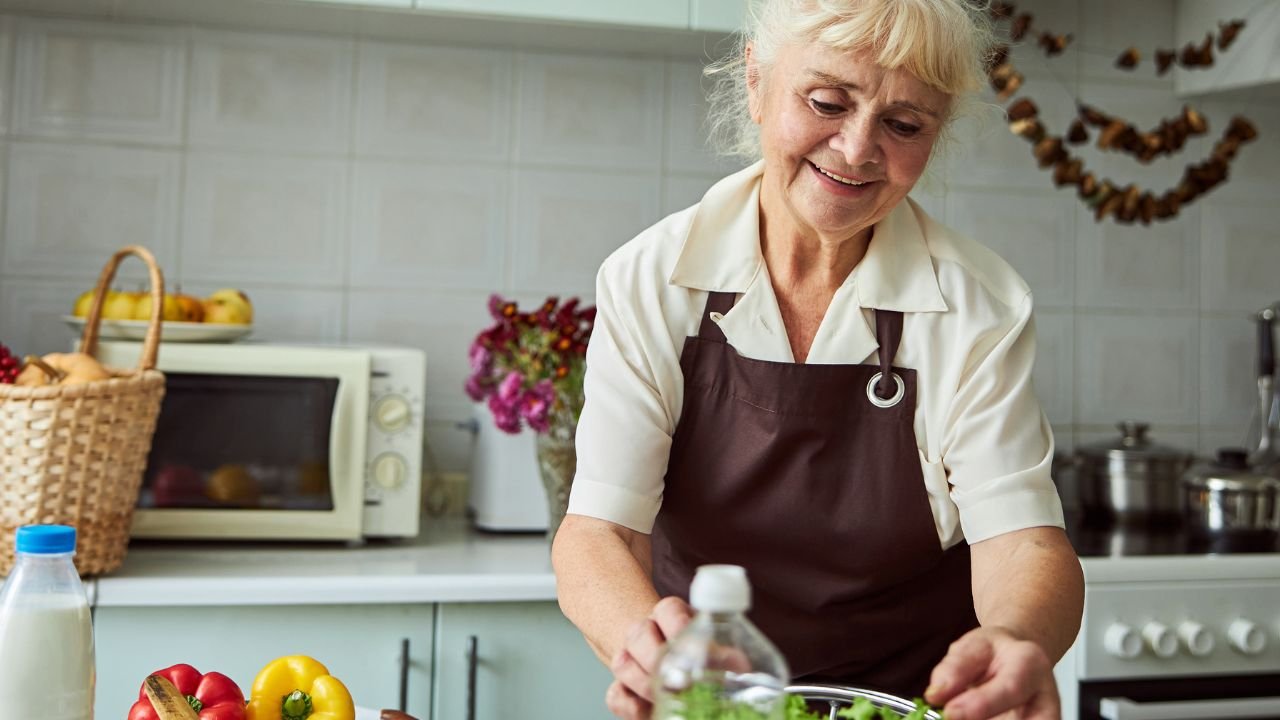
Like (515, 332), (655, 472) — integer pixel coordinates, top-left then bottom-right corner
(97, 341), (426, 541)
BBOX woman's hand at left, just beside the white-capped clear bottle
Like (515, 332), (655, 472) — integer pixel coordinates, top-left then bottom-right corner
(604, 596), (694, 720)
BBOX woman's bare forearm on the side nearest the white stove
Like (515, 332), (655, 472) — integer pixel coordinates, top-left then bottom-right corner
(972, 528), (1084, 662)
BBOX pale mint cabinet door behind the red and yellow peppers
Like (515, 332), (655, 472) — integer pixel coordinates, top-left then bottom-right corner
(93, 603), (435, 719)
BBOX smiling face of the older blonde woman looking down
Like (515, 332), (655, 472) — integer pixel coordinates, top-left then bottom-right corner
(749, 44), (950, 238)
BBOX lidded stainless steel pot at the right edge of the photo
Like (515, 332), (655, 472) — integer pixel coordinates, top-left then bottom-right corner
(1181, 448), (1280, 536)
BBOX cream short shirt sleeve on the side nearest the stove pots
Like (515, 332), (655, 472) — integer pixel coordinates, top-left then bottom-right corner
(942, 288), (1064, 543)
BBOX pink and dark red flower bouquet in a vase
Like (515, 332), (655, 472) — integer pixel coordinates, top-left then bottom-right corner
(465, 295), (595, 538)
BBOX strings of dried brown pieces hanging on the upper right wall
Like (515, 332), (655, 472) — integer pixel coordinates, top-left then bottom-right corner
(988, 3), (1258, 225)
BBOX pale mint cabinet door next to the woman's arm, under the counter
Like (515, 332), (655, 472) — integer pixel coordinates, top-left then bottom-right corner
(433, 602), (612, 720)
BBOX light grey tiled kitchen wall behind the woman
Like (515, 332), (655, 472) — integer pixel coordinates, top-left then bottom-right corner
(0, 0), (1280, 470)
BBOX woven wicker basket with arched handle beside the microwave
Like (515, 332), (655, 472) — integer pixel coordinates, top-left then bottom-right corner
(0, 246), (164, 575)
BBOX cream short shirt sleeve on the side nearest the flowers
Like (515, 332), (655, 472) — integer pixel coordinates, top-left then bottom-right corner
(568, 257), (678, 533)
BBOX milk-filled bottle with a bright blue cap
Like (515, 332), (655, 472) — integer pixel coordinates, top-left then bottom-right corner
(0, 525), (93, 720)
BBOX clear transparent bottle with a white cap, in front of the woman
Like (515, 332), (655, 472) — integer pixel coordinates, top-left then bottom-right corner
(654, 565), (791, 720)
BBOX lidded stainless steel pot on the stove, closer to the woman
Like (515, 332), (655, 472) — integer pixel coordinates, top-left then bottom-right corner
(1074, 421), (1193, 524)
